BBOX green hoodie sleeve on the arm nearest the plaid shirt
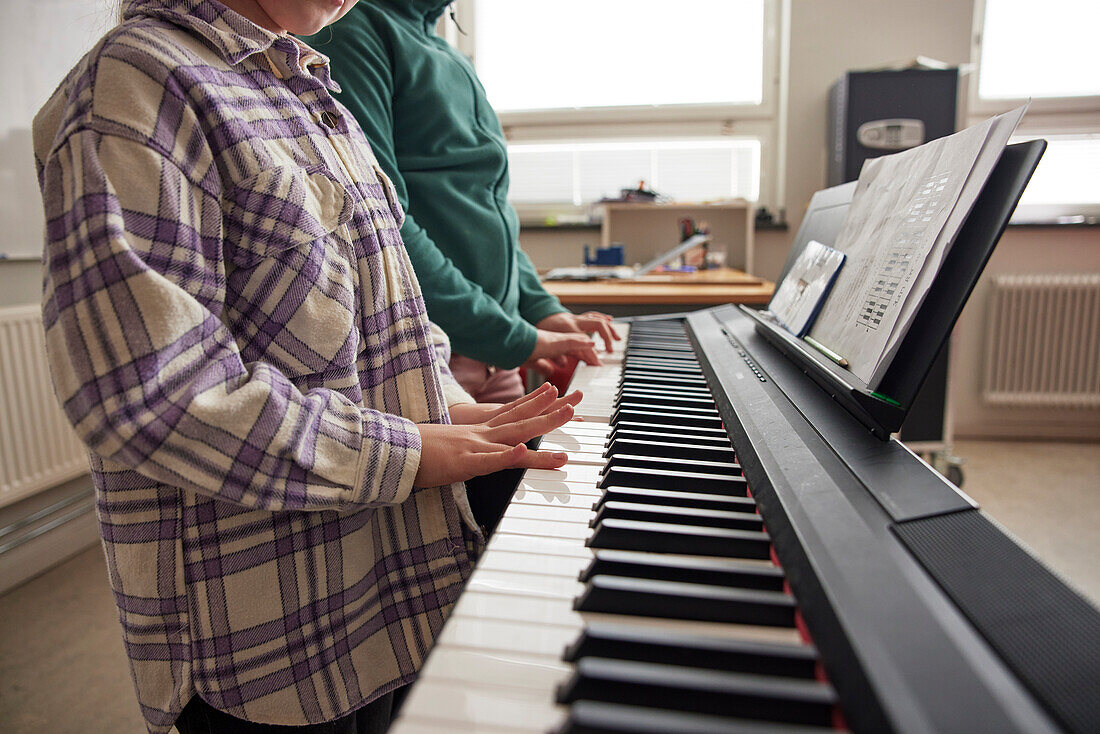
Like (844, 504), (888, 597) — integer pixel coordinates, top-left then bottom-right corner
(307, 22), (536, 369)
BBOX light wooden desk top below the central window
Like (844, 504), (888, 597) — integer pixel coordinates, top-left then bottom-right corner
(542, 267), (776, 316)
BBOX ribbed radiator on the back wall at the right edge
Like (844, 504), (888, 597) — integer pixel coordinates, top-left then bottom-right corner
(982, 273), (1100, 408)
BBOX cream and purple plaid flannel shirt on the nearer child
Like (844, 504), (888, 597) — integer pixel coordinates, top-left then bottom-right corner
(34, 0), (479, 732)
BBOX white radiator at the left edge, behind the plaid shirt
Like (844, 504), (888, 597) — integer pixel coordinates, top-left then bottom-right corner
(0, 306), (88, 506)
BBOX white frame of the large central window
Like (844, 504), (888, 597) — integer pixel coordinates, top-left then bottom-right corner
(440, 0), (790, 218)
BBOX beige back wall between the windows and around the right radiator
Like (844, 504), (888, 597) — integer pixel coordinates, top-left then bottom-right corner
(524, 0), (1100, 440)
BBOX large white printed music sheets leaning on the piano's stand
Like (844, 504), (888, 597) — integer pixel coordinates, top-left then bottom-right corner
(810, 107), (1026, 390)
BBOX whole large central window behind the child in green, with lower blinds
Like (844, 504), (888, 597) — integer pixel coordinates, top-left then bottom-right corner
(448, 0), (781, 218)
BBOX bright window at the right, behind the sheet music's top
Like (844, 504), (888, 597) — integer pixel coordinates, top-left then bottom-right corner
(970, 0), (1100, 221)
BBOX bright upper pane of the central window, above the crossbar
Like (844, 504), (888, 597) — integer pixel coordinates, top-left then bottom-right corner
(473, 0), (763, 112)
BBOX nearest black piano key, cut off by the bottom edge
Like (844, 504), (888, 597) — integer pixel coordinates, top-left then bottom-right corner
(554, 701), (831, 734)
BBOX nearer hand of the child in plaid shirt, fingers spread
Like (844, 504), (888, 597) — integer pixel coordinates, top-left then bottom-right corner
(413, 385), (573, 486)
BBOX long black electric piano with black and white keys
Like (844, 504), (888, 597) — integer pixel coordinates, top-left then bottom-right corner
(391, 309), (1100, 734)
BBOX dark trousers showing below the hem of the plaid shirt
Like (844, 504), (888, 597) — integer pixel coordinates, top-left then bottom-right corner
(176, 686), (409, 734)
